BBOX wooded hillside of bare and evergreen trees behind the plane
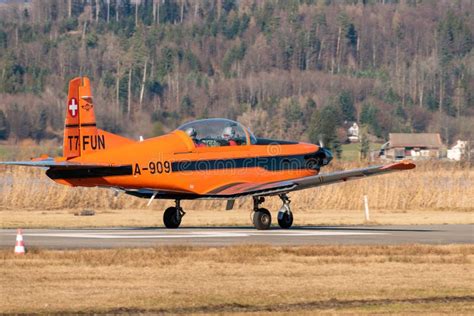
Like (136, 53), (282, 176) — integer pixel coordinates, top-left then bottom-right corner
(0, 0), (474, 152)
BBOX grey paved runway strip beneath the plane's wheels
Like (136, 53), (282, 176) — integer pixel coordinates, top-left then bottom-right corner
(0, 225), (474, 249)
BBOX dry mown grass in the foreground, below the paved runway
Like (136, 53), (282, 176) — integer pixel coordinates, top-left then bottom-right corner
(0, 245), (474, 314)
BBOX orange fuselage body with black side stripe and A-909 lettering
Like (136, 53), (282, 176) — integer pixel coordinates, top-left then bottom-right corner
(47, 130), (330, 195)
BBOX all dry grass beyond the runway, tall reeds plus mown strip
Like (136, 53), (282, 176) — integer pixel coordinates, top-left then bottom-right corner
(0, 163), (474, 228)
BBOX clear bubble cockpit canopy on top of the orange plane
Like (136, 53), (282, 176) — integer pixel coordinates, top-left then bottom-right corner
(178, 118), (257, 147)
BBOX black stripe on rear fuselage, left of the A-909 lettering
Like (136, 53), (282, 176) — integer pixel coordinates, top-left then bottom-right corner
(46, 165), (133, 179)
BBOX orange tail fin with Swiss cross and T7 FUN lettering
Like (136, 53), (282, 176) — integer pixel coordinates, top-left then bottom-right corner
(63, 77), (133, 159)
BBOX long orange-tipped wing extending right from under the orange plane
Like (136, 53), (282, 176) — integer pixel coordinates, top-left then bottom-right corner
(198, 161), (415, 199)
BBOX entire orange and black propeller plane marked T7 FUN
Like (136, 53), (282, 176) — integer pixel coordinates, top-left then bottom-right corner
(1, 77), (415, 229)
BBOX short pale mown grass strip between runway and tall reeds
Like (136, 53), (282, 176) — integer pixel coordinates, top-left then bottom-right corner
(0, 209), (474, 228)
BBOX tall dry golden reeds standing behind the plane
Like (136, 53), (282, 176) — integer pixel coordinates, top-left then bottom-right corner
(0, 163), (474, 211)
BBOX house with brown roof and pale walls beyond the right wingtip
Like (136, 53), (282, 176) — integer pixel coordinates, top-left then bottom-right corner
(380, 133), (444, 160)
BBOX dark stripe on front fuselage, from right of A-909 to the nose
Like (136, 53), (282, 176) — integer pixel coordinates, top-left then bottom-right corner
(171, 154), (312, 172)
